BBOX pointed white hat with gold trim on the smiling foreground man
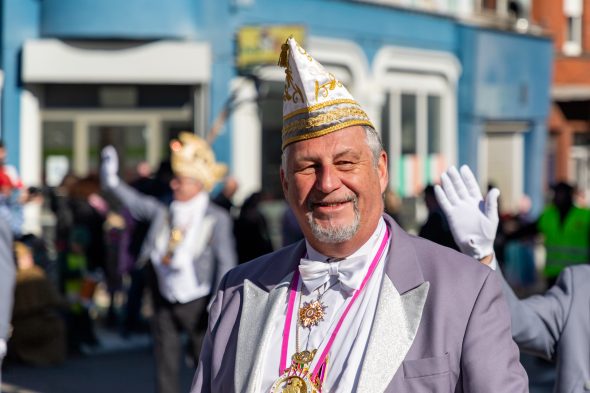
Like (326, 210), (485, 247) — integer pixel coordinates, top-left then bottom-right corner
(279, 37), (373, 149)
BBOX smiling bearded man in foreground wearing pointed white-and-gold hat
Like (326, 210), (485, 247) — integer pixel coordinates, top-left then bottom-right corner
(192, 38), (527, 393)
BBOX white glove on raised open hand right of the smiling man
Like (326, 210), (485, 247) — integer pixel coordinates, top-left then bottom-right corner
(434, 165), (500, 259)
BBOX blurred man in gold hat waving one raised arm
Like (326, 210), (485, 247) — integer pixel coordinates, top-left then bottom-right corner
(101, 132), (237, 393)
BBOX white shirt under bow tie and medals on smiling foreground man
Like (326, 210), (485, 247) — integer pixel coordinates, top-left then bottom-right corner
(262, 219), (389, 393)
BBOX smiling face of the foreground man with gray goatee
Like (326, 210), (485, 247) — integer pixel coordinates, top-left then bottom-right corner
(281, 126), (387, 251)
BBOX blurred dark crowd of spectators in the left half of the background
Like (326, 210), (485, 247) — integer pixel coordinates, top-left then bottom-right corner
(0, 142), (303, 366)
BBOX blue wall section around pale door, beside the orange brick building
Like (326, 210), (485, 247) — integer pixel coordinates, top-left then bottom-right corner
(458, 26), (553, 213)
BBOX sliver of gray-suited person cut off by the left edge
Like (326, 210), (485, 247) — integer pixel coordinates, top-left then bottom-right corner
(0, 214), (16, 385)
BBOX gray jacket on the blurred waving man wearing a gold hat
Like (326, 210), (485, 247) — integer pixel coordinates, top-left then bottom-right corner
(109, 182), (237, 291)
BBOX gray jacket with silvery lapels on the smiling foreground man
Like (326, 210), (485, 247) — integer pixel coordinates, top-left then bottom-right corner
(191, 216), (528, 393)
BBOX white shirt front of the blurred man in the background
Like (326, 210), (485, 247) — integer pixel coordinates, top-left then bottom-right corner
(151, 192), (211, 303)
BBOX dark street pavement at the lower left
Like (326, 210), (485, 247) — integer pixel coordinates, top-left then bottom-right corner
(2, 331), (194, 393)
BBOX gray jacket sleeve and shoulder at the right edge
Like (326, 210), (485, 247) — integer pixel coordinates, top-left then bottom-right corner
(504, 265), (590, 393)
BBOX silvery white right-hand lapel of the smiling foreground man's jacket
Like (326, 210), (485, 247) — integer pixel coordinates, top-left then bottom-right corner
(357, 276), (430, 393)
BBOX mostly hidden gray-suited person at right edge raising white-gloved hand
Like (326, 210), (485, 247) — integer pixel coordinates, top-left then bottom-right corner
(436, 166), (590, 393)
